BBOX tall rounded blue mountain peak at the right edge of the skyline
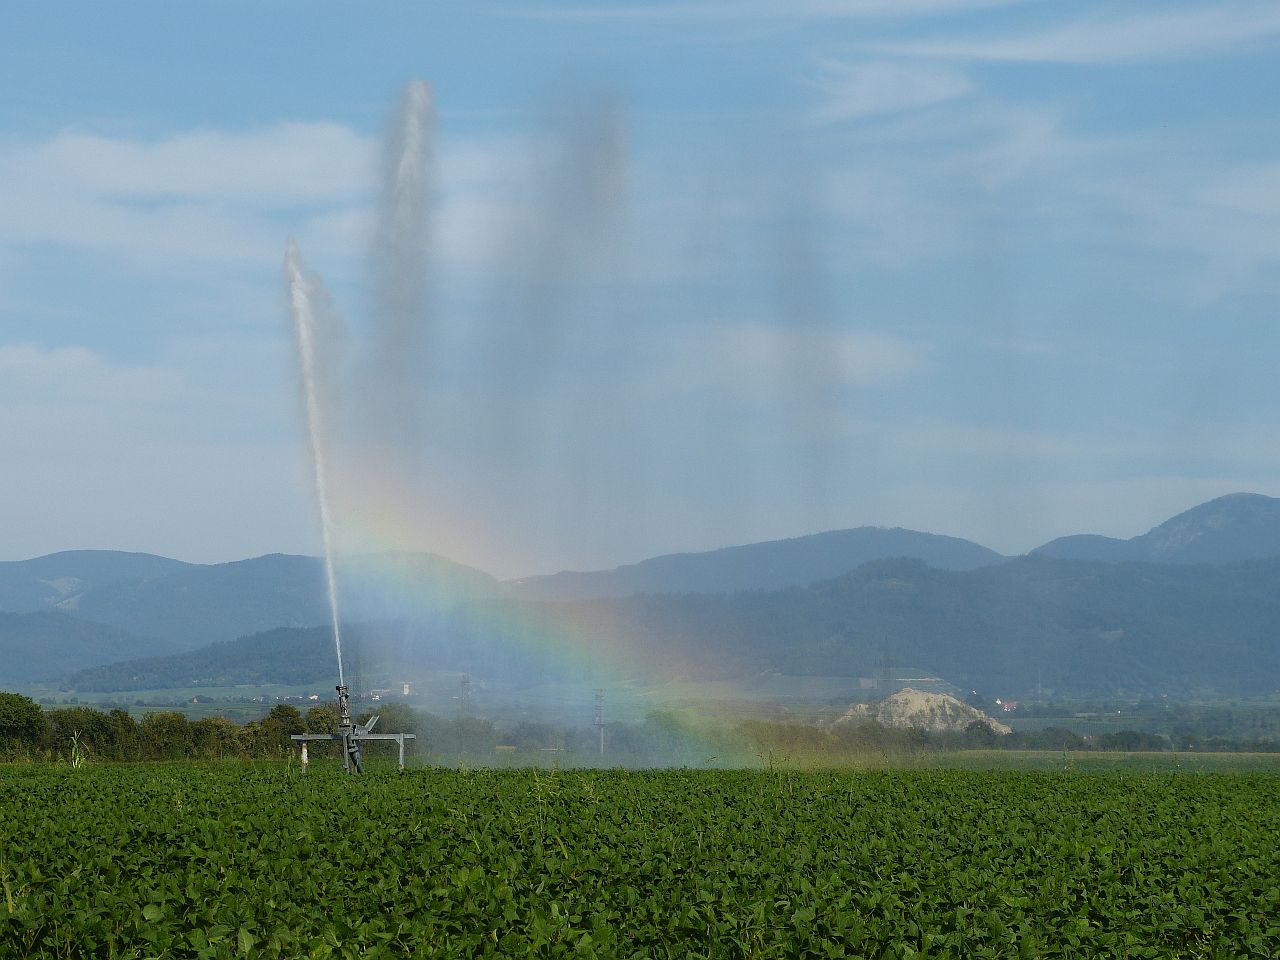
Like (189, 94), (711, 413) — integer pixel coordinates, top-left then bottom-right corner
(1032, 493), (1280, 564)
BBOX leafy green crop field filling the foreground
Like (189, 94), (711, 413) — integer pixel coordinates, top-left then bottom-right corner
(0, 762), (1280, 960)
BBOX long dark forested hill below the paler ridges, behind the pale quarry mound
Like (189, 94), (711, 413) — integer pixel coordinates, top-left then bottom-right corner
(64, 557), (1280, 698)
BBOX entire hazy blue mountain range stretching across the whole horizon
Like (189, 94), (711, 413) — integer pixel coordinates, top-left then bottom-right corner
(0, 494), (1280, 690)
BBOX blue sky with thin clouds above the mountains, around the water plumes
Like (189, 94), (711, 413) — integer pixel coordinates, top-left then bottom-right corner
(0, 0), (1280, 575)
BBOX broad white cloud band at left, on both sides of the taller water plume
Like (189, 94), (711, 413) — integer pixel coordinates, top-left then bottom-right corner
(0, 123), (560, 273)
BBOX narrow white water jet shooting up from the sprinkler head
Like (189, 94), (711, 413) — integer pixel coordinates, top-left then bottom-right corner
(284, 238), (347, 685)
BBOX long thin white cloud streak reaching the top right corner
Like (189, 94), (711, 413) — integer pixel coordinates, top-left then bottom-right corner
(879, 3), (1280, 64)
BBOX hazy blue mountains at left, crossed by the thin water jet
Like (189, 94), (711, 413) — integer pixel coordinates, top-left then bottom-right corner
(0, 550), (500, 689)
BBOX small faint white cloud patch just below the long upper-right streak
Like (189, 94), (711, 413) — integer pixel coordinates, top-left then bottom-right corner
(812, 60), (973, 123)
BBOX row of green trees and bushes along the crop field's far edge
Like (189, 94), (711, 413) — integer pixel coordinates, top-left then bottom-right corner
(0, 692), (1280, 767)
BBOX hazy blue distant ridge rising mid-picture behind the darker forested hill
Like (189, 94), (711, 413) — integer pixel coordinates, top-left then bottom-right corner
(504, 526), (1005, 600)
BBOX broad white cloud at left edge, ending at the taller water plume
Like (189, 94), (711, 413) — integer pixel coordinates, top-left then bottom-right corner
(0, 124), (372, 264)
